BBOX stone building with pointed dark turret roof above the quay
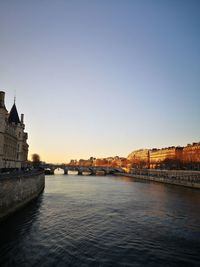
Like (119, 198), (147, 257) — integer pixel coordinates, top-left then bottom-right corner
(0, 91), (28, 171)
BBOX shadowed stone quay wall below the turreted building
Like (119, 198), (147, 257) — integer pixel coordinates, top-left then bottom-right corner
(0, 170), (45, 220)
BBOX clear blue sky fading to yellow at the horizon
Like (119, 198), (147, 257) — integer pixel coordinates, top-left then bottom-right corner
(0, 0), (200, 163)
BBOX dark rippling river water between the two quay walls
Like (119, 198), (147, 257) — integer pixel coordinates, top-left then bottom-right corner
(0, 175), (200, 267)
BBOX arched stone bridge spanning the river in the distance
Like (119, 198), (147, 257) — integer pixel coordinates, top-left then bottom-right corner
(41, 164), (124, 176)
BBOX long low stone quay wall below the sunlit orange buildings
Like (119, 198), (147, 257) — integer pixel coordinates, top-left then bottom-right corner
(117, 169), (200, 189)
